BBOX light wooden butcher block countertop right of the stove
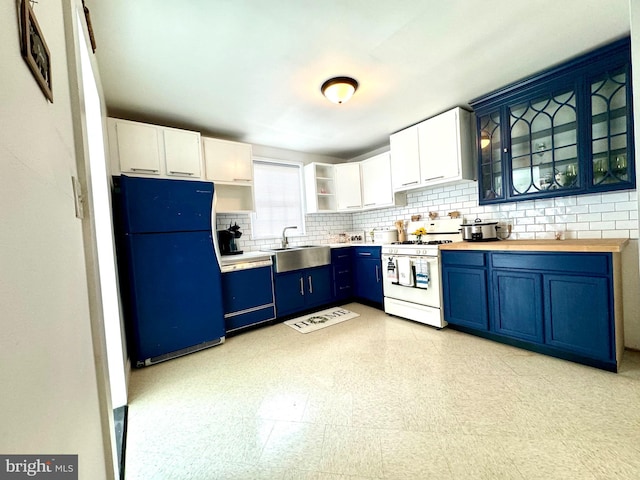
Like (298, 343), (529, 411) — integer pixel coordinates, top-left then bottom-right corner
(440, 238), (629, 253)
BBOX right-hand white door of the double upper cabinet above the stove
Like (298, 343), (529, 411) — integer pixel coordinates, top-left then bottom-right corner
(418, 108), (461, 185)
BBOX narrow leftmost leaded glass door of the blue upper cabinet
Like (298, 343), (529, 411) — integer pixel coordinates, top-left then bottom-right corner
(478, 110), (504, 202)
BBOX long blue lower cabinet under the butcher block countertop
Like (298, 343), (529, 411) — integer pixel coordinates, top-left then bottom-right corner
(442, 251), (617, 371)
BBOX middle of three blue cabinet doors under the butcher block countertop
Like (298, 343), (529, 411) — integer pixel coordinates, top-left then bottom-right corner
(492, 270), (544, 343)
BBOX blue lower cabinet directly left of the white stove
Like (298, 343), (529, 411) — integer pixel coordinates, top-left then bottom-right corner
(353, 246), (384, 306)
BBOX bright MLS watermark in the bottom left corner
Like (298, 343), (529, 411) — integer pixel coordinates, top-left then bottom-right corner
(0, 455), (78, 480)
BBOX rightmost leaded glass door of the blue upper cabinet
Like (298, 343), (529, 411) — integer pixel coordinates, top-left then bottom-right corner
(590, 67), (633, 189)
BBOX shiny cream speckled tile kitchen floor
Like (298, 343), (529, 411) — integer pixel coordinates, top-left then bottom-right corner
(126, 303), (640, 480)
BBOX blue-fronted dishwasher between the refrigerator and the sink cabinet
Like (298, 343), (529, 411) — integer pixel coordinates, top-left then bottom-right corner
(221, 257), (276, 333)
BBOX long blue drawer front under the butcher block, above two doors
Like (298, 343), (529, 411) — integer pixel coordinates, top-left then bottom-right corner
(491, 252), (611, 275)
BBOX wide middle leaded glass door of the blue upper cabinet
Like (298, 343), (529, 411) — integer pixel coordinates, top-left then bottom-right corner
(509, 89), (580, 197)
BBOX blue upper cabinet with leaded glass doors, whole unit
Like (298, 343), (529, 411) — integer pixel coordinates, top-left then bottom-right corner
(471, 39), (635, 204)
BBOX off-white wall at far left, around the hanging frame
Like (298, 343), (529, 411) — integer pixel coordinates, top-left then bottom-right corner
(0, 0), (113, 479)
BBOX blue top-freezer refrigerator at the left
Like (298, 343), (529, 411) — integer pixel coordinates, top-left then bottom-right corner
(114, 175), (225, 367)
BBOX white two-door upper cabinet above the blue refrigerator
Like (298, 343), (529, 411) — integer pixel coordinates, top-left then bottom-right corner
(107, 118), (202, 179)
